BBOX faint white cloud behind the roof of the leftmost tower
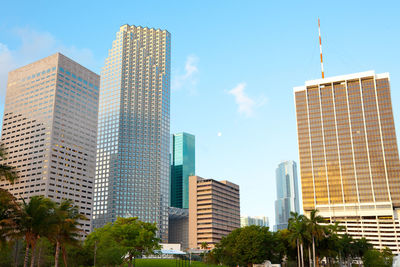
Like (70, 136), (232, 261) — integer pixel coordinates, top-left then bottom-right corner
(0, 28), (99, 98)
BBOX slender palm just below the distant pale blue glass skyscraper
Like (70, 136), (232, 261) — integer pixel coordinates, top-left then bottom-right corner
(288, 212), (308, 267)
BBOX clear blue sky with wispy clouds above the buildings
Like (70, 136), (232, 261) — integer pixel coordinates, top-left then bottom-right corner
(0, 0), (400, 225)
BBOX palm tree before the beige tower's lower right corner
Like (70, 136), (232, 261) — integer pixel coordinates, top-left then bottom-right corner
(48, 200), (87, 267)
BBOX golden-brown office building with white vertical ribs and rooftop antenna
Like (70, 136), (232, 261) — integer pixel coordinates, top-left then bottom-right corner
(294, 71), (400, 254)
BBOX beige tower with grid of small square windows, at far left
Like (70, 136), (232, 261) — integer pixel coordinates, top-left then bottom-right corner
(0, 53), (100, 234)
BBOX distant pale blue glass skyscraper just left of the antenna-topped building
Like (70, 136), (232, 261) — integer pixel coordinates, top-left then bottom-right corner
(274, 160), (300, 230)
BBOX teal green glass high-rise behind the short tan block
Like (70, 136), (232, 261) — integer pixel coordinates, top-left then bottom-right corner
(170, 133), (195, 209)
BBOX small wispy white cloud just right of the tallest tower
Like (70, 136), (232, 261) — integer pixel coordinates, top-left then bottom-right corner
(172, 55), (199, 92)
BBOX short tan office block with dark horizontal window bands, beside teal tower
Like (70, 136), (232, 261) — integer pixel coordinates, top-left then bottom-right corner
(189, 176), (240, 249)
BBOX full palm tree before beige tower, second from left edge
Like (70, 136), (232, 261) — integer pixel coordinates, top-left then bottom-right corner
(17, 196), (54, 267)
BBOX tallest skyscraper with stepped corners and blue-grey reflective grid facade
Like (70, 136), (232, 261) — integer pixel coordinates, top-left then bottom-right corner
(93, 25), (171, 241)
